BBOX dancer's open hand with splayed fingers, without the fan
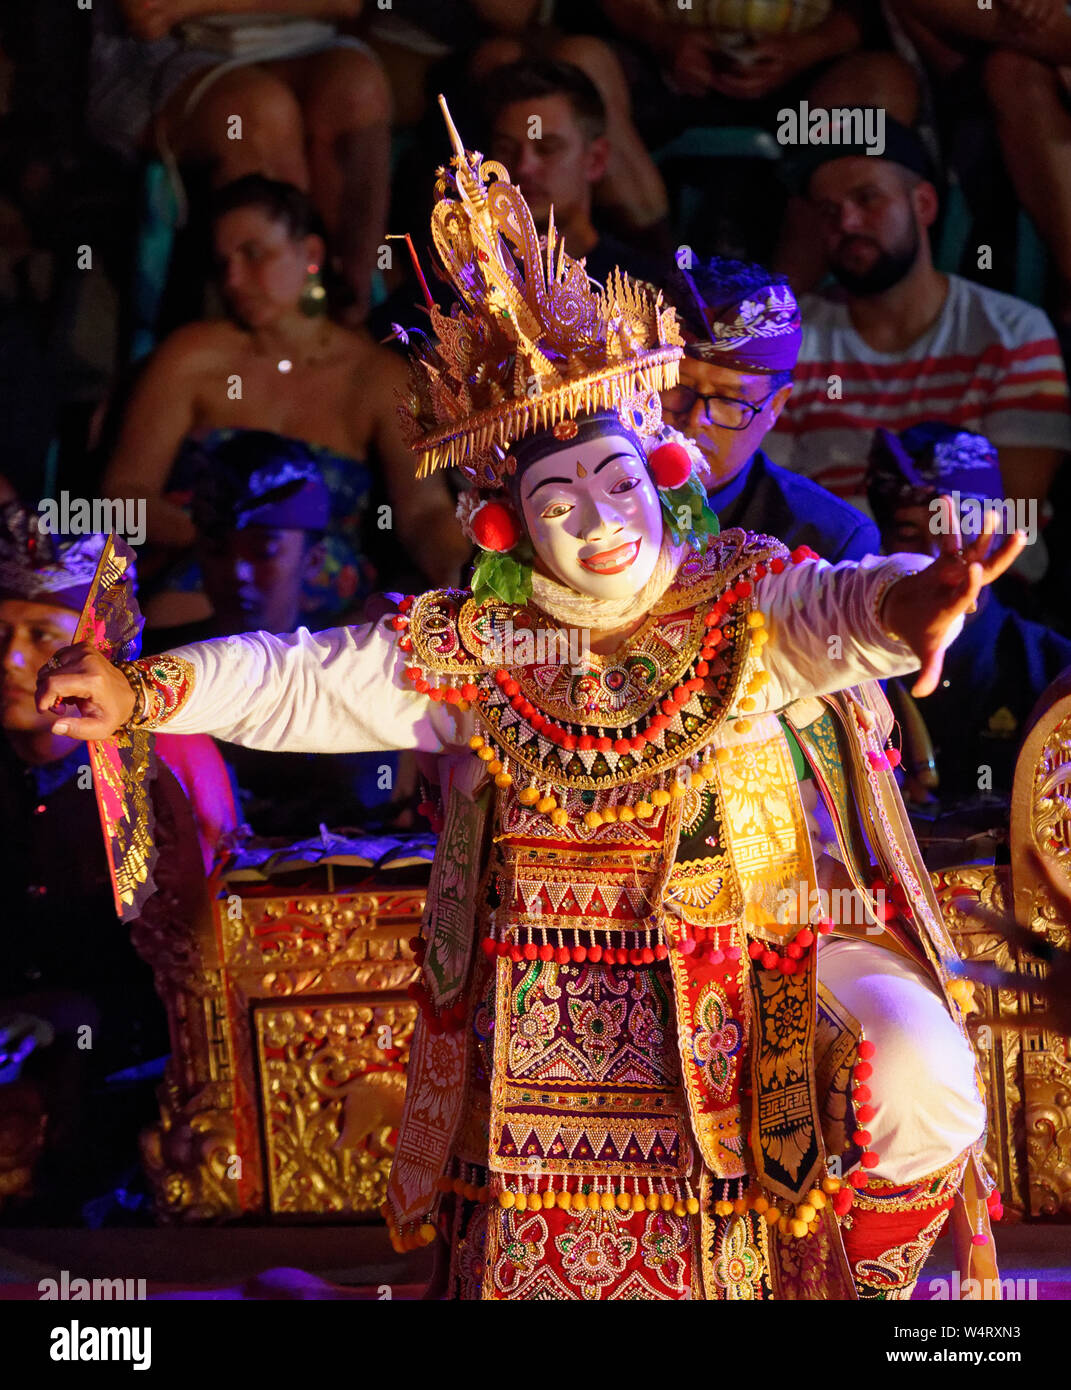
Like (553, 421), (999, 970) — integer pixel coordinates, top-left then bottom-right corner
(882, 498), (1027, 696)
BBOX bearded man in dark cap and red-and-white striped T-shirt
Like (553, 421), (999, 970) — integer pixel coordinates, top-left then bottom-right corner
(767, 120), (1071, 564)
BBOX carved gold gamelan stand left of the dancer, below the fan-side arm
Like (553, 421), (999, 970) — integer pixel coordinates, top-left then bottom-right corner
(135, 817), (424, 1222)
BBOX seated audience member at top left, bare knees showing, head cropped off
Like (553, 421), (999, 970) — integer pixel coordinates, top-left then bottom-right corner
(86, 0), (390, 325)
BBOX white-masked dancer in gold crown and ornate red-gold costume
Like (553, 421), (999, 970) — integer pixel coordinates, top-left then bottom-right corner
(39, 100), (1021, 1300)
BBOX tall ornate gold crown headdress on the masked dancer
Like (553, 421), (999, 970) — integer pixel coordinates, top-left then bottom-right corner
(400, 96), (683, 487)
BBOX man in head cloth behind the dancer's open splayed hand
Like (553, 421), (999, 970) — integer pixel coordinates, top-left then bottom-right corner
(867, 421), (1071, 808)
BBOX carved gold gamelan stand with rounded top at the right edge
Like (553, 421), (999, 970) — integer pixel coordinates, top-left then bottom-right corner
(932, 674), (1071, 1220)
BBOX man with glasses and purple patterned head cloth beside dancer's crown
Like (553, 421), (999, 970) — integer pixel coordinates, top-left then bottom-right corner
(663, 257), (878, 563)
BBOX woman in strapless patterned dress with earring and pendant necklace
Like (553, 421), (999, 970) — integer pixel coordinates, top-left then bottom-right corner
(101, 174), (470, 645)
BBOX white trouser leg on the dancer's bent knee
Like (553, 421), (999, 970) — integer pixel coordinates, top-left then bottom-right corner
(818, 938), (985, 1183)
